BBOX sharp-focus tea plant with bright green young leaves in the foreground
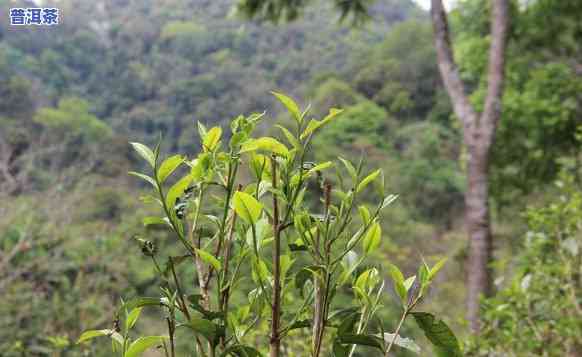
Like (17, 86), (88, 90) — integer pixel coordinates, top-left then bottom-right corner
(79, 93), (460, 357)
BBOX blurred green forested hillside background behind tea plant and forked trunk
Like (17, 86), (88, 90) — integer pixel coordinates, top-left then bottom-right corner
(0, 0), (582, 356)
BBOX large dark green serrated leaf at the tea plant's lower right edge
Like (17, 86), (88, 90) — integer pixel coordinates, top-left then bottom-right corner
(411, 312), (463, 357)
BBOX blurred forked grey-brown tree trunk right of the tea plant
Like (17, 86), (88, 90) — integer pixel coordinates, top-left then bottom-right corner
(431, 0), (509, 333)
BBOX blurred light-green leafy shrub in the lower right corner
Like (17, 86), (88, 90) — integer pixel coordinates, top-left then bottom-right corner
(469, 175), (582, 356)
